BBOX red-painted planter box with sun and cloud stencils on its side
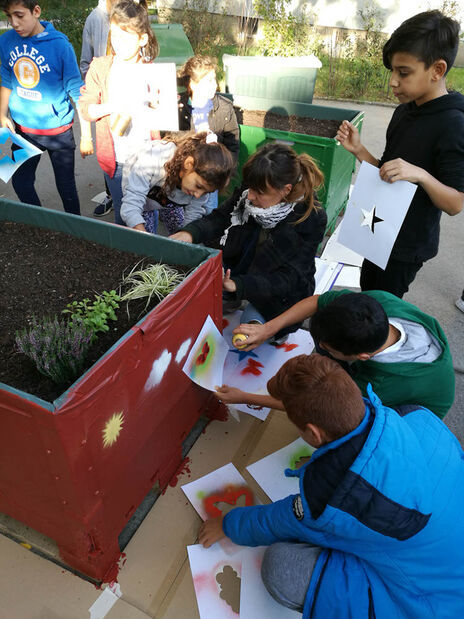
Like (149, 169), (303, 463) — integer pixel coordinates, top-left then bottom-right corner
(0, 200), (222, 581)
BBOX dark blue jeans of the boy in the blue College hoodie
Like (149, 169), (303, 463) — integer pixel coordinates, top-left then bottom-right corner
(11, 127), (81, 215)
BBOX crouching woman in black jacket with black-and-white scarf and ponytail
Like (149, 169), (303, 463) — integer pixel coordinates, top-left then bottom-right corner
(173, 144), (327, 338)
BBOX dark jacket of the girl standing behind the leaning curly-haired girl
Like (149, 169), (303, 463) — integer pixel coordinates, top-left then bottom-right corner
(179, 92), (240, 162)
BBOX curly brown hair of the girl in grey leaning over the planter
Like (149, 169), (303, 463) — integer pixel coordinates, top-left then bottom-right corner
(164, 131), (235, 191)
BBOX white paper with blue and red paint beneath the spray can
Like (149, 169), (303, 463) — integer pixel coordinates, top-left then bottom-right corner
(222, 311), (314, 420)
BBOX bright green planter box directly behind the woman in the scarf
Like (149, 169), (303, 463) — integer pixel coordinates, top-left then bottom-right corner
(227, 95), (364, 232)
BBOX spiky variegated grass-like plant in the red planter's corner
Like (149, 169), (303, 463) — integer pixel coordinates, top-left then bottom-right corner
(121, 262), (185, 311)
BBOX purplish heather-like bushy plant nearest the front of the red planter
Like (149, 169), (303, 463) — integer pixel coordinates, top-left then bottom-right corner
(15, 316), (92, 384)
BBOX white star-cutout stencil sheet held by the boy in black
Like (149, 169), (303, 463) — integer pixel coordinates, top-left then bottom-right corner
(339, 161), (417, 269)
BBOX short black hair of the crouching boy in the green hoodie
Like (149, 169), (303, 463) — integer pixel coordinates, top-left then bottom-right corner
(309, 292), (389, 355)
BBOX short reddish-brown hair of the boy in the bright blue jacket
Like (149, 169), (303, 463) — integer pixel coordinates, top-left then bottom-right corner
(267, 353), (365, 440)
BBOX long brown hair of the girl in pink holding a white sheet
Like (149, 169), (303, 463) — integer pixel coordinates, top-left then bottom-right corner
(108, 0), (159, 63)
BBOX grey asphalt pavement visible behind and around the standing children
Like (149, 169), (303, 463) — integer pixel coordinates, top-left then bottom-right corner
(0, 99), (464, 445)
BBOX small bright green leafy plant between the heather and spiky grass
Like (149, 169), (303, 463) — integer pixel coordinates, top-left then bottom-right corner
(63, 290), (121, 341)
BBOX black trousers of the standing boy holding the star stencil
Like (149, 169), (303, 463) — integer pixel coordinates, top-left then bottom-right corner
(361, 259), (424, 299)
